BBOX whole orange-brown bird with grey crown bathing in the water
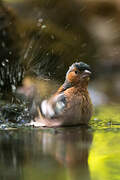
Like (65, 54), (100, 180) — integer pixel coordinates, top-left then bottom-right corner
(18, 62), (93, 127)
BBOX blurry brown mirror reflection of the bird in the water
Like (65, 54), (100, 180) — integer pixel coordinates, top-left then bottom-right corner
(39, 127), (92, 180)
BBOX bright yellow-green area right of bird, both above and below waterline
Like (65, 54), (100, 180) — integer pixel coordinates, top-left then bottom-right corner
(88, 105), (120, 180)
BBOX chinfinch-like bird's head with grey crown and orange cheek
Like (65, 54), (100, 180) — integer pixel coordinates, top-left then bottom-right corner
(66, 62), (91, 86)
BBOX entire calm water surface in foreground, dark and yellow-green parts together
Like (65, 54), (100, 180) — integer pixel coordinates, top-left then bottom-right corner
(0, 127), (120, 180)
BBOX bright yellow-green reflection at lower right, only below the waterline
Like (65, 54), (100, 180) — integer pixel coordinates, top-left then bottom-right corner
(88, 131), (120, 180)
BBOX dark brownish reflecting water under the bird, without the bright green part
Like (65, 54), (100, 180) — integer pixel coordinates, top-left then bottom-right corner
(0, 127), (92, 180)
